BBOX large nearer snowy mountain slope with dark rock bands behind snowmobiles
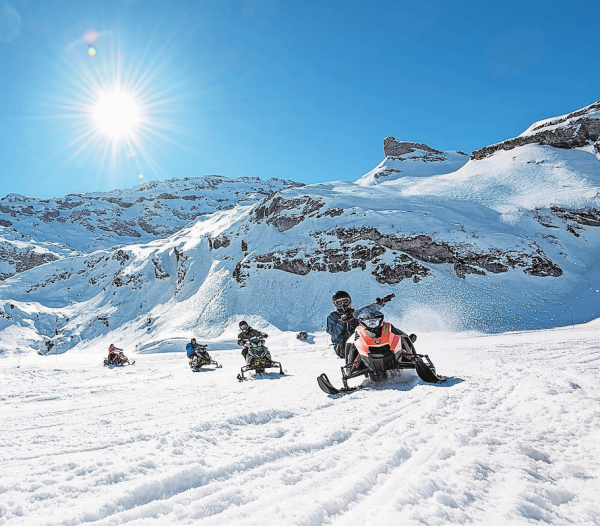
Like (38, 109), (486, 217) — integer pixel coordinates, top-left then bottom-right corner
(0, 103), (600, 352)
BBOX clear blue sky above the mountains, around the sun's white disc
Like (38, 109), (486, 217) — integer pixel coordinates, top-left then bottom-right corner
(0, 0), (600, 197)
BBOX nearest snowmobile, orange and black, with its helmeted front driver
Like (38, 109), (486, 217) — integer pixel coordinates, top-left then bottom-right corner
(317, 305), (446, 395)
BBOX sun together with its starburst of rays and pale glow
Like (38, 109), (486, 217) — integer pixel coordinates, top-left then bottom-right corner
(52, 31), (184, 187)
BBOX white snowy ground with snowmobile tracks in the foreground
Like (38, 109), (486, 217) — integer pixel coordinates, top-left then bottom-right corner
(0, 326), (600, 526)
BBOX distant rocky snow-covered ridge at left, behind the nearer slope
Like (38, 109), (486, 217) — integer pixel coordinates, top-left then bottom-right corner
(0, 175), (304, 280)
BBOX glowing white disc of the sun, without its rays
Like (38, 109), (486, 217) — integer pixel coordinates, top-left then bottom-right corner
(92, 88), (142, 141)
